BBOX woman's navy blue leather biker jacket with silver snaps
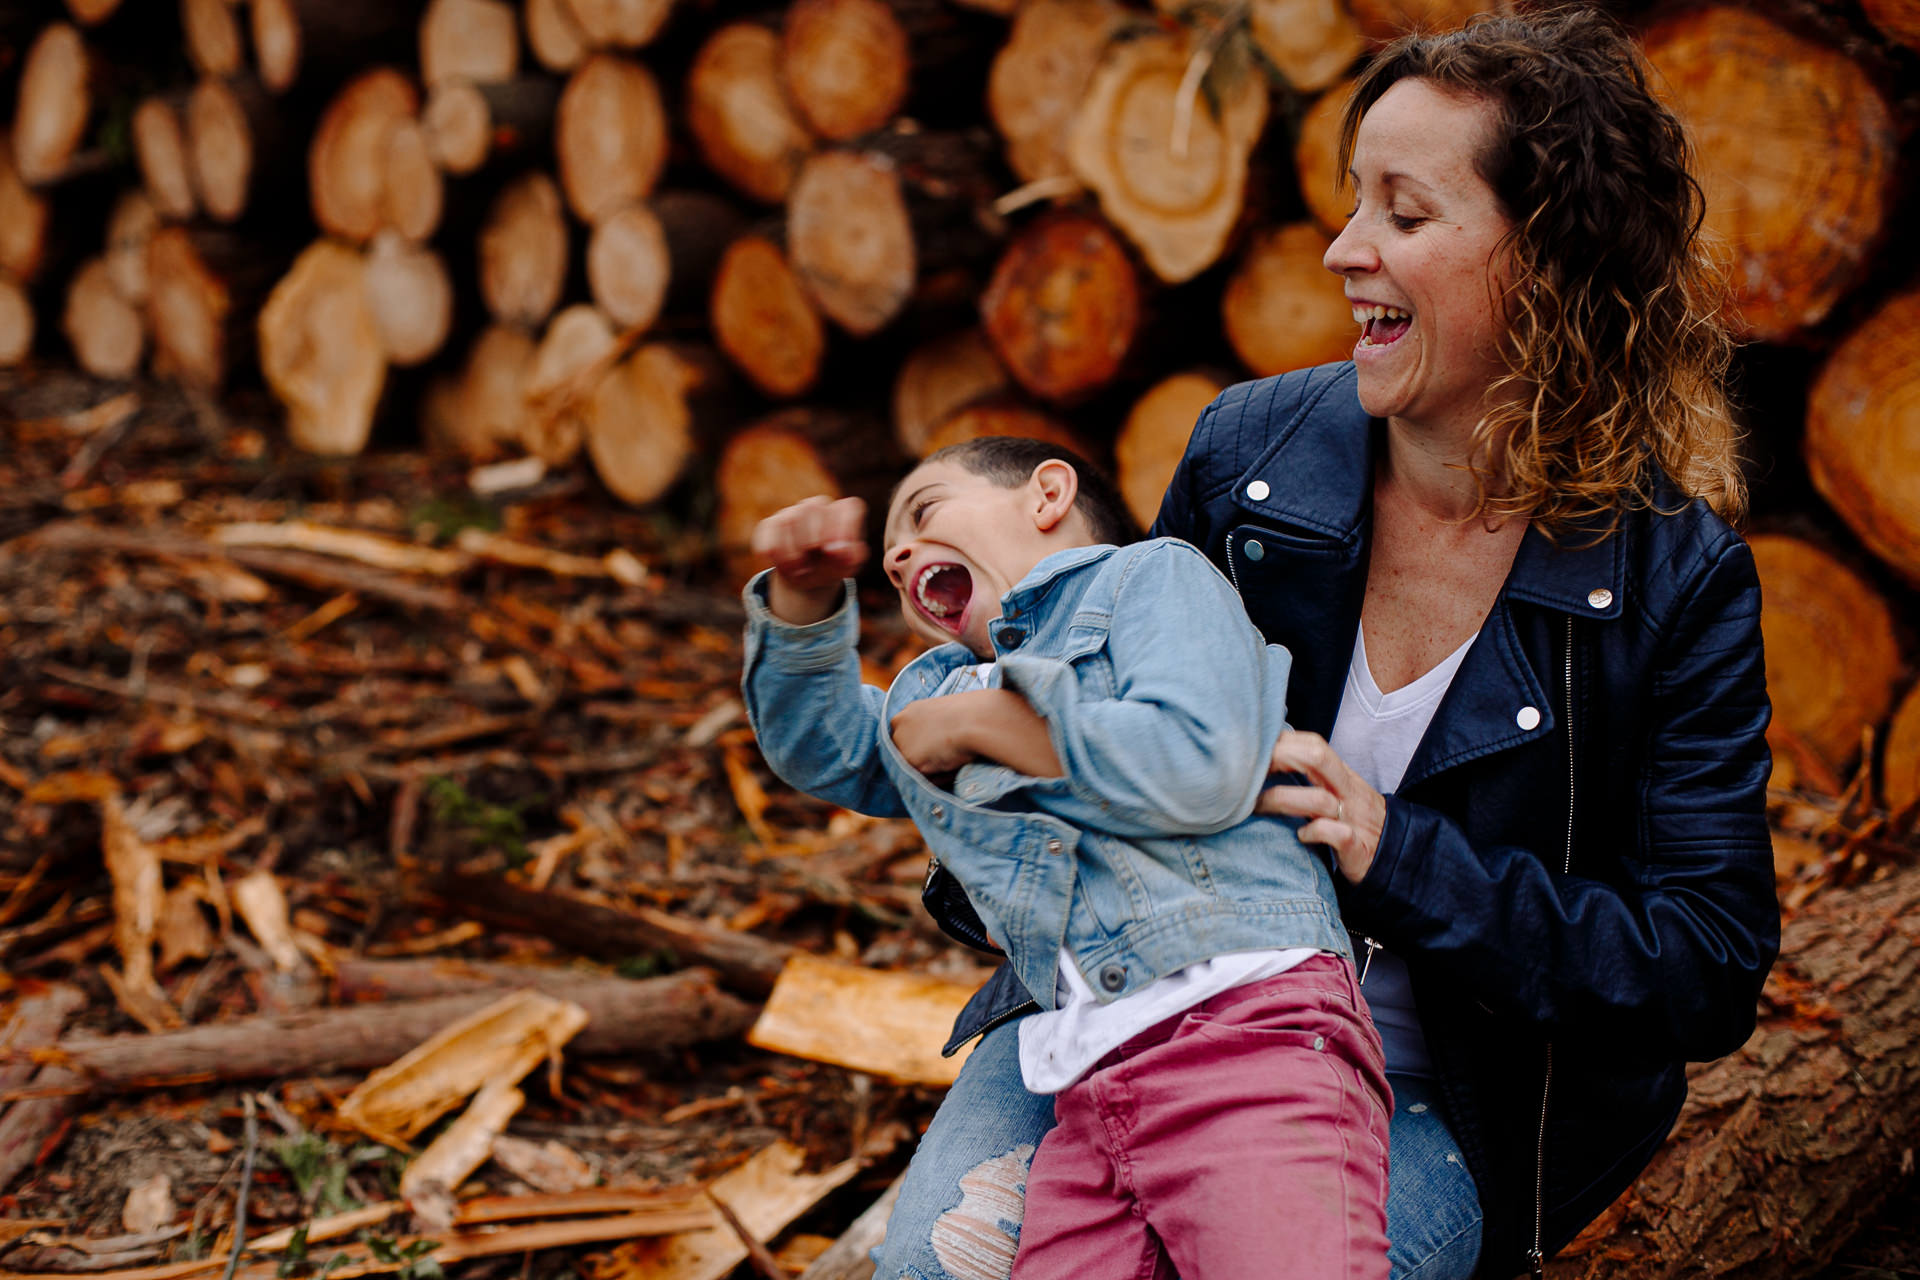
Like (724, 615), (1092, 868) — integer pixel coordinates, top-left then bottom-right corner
(936, 365), (1780, 1276)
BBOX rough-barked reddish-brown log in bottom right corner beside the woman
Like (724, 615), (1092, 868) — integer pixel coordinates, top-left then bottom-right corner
(1548, 867), (1920, 1280)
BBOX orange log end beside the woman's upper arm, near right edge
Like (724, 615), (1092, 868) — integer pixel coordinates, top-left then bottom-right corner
(1749, 533), (1903, 770)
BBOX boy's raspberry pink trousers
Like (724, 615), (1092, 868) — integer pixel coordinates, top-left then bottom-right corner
(1012, 956), (1394, 1280)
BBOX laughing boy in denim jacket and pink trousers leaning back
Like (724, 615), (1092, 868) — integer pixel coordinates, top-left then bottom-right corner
(743, 439), (1392, 1280)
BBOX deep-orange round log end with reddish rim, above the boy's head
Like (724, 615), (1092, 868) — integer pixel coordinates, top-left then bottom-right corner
(979, 213), (1140, 403)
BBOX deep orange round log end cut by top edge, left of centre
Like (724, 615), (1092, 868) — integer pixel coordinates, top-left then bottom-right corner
(780, 0), (910, 142)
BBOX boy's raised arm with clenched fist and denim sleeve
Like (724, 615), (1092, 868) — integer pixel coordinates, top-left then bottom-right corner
(741, 499), (906, 818)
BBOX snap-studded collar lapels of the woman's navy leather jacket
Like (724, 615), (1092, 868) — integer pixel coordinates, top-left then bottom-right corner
(1231, 365), (1626, 618)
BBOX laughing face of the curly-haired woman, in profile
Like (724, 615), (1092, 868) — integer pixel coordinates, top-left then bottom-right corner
(1325, 81), (1511, 430)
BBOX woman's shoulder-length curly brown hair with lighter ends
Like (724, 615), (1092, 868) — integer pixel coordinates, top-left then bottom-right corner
(1340, 8), (1745, 535)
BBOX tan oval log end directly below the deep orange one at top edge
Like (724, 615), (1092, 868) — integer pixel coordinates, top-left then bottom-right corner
(787, 152), (918, 338)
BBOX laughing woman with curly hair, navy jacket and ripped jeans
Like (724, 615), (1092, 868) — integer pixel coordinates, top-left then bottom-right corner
(877, 12), (1778, 1280)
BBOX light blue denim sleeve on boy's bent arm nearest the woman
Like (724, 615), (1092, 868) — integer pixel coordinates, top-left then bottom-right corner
(987, 541), (1286, 837)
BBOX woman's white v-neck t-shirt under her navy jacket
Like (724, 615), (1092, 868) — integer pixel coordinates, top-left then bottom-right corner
(1327, 628), (1473, 1075)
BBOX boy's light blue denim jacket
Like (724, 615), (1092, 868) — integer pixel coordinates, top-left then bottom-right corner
(741, 537), (1352, 1009)
